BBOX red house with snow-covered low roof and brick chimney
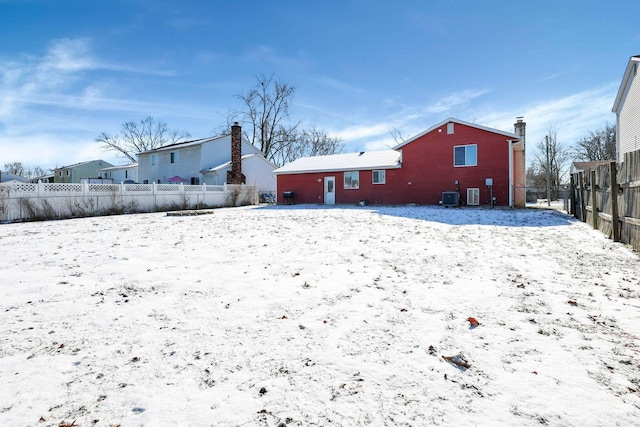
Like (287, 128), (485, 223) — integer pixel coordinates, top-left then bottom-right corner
(274, 118), (525, 207)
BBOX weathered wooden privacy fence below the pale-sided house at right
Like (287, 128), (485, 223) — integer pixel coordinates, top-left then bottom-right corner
(571, 150), (640, 251)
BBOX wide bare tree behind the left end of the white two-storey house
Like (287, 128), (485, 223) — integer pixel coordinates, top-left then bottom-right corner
(95, 116), (191, 163)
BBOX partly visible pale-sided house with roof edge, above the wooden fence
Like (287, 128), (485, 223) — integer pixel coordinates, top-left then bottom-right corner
(612, 55), (640, 162)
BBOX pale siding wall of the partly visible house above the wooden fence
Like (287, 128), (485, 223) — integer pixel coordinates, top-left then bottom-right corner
(617, 63), (640, 161)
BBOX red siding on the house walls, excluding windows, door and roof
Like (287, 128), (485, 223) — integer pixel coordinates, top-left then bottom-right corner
(277, 123), (510, 206)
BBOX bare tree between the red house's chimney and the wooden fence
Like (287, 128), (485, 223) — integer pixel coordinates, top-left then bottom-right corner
(532, 128), (571, 199)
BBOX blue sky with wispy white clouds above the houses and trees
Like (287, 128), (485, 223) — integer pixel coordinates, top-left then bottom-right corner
(0, 0), (640, 171)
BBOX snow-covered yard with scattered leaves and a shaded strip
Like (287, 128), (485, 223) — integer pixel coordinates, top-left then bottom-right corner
(0, 206), (640, 427)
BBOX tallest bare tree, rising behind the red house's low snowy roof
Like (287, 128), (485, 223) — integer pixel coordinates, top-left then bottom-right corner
(227, 74), (343, 166)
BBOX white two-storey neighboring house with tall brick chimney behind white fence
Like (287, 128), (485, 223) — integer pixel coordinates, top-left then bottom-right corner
(138, 125), (276, 191)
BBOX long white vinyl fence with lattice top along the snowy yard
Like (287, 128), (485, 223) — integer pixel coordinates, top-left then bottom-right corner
(0, 183), (258, 222)
